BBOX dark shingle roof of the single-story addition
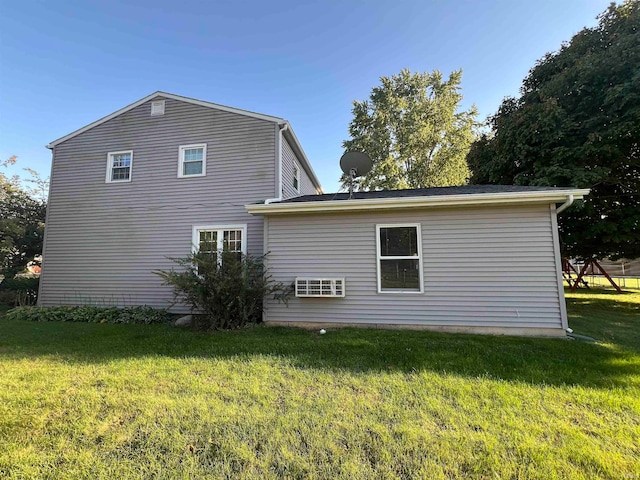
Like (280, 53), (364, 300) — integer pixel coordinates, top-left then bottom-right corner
(274, 185), (567, 203)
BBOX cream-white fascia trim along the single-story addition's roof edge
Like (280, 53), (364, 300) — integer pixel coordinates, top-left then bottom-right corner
(245, 189), (589, 215)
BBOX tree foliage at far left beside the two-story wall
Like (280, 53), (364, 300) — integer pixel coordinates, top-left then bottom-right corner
(0, 157), (46, 278)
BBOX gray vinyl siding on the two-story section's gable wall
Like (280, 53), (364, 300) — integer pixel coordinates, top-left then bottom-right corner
(39, 98), (277, 306)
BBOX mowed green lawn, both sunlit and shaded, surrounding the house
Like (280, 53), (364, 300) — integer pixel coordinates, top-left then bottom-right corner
(0, 292), (640, 480)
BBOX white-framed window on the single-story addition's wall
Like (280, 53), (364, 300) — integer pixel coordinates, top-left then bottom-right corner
(376, 224), (423, 293)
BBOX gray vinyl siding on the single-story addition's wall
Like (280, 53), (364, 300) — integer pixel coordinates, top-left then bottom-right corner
(267, 205), (564, 329)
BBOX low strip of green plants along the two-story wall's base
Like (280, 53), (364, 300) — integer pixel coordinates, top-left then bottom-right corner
(5, 305), (175, 325)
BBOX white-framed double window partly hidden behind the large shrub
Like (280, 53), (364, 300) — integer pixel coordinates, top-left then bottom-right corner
(193, 225), (247, 263)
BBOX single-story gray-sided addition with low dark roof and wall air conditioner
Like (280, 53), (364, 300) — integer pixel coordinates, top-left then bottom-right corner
(247, 185), (588, 336)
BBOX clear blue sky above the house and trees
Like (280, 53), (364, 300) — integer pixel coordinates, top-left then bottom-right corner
(0, 0), (609, 191)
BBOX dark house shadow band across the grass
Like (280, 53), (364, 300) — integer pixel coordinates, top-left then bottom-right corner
(0, 319), (640, 388)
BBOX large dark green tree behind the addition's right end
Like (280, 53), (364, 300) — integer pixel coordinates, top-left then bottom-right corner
(467, 0), (640, 260)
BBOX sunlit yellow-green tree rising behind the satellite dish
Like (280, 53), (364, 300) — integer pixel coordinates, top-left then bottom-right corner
(343, 69), (477, 190)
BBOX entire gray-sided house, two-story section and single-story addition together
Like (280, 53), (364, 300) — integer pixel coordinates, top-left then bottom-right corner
(39, 92), (588, 336)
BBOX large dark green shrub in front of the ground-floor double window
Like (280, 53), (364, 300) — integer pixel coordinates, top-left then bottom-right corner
(154, 251), (291, 330)
